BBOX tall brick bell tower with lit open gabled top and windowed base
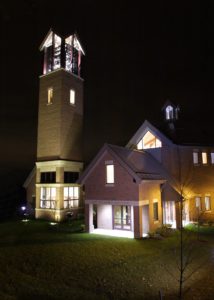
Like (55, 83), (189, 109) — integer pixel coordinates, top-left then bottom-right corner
(35, 29), (84, 221)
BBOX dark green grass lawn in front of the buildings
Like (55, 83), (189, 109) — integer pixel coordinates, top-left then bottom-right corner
(0, 220), (214, 300)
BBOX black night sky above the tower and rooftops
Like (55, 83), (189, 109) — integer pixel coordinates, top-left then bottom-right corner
(0, 0), (214, 211)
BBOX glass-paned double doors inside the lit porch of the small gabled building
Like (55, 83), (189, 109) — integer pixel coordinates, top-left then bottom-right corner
(114, 205), (131, 230)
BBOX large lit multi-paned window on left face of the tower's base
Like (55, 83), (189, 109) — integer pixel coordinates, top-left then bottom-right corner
(40, 187), (56, 209)
